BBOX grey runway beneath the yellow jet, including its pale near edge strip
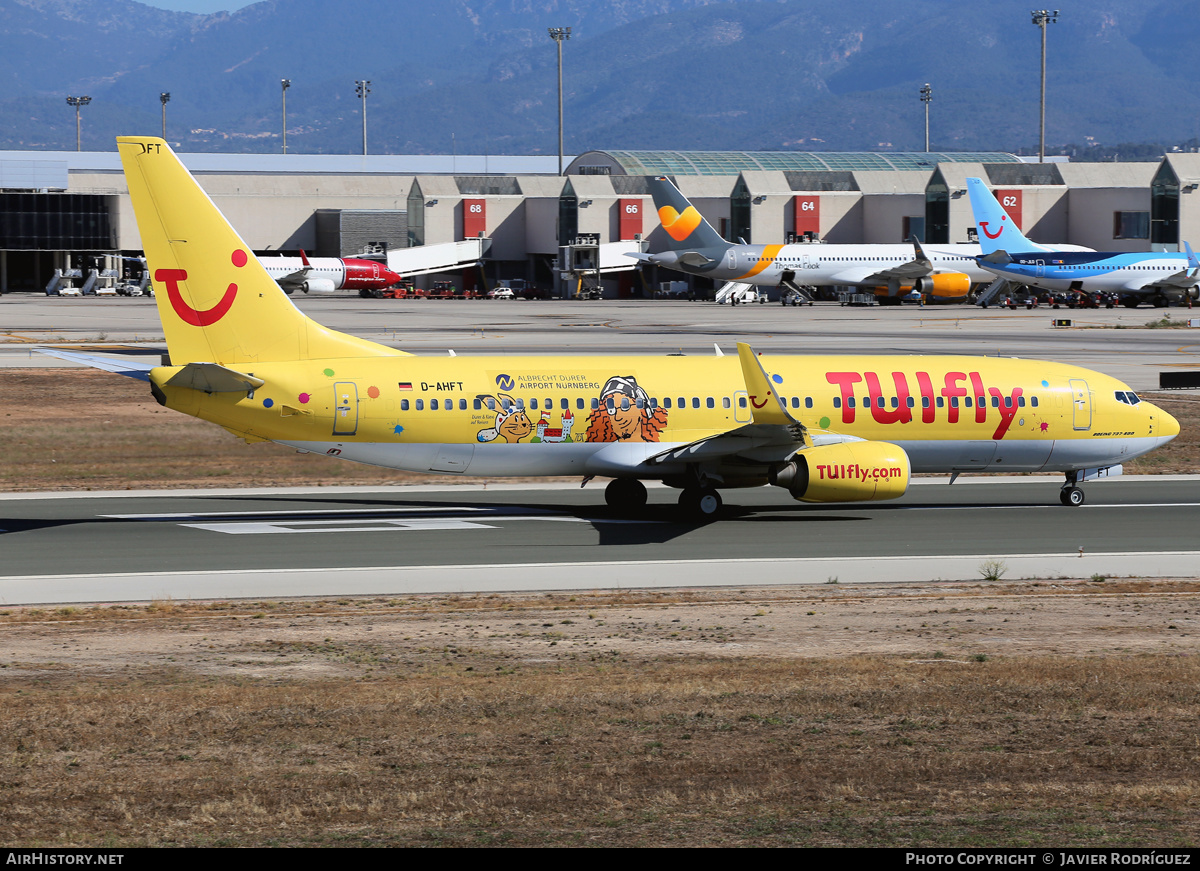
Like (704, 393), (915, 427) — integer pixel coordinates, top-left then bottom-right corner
(0, 477), (1200, 605)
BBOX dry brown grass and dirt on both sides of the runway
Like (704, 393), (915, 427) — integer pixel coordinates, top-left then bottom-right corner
(0, 370), (1200, 847)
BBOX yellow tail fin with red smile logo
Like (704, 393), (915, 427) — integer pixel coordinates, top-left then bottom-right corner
(116, 137), (403, 365)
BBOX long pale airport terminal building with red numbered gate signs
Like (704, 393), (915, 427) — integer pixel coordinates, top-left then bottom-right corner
(0, 151), (1200, 296)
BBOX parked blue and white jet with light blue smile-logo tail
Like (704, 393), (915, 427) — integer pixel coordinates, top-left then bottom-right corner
(967, 179), (1200, 307)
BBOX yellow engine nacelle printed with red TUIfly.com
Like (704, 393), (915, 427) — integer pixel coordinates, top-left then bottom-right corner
(768, 441), (912, 503)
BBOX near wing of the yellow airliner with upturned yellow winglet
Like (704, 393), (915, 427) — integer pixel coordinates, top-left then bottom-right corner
(646, 342), (812, 465)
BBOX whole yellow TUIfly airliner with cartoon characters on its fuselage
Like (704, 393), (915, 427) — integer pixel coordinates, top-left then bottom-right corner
(51, 137), (1178, 517)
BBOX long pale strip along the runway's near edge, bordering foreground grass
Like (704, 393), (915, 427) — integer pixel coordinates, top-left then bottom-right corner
(0, 551), (1200, 605)
